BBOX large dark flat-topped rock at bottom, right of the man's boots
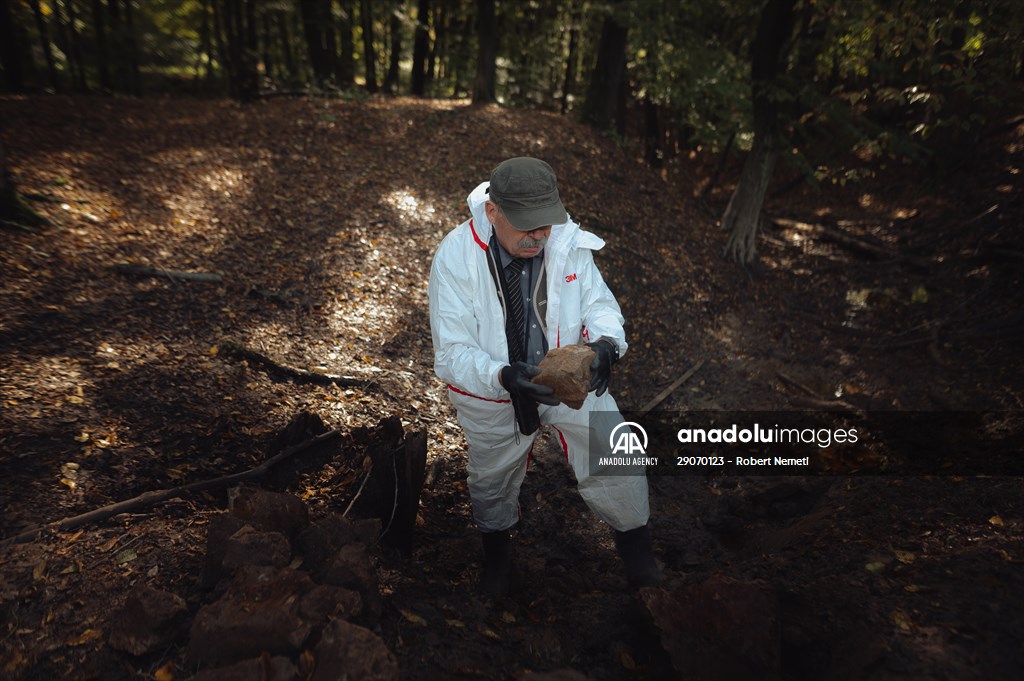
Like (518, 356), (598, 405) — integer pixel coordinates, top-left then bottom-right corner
(640, 577), (781, 681)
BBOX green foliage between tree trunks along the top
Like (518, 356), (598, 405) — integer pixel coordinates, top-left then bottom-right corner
(4, 0), (1024, 181)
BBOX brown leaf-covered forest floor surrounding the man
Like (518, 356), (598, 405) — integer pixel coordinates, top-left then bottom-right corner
(0, 97), (1024, 680)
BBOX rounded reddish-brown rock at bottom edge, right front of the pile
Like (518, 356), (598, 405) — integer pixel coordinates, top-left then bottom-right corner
(312, 620), (398, 681)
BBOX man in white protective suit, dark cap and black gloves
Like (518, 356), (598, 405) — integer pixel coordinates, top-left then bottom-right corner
(429, 158), (660, 596)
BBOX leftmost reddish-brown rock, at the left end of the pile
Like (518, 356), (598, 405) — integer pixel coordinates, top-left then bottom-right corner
(109, 585), (188, 655)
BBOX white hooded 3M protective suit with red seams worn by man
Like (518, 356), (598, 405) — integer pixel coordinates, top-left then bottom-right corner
(428, 182), (649, 533)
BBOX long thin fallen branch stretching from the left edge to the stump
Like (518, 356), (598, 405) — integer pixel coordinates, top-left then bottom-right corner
(0, 429), (341, 545)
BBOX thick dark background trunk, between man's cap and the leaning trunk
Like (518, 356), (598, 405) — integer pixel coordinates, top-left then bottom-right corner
(583, 0), (629, 130)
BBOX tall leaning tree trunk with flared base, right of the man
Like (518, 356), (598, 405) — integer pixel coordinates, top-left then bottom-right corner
(722, 0), (797, 264)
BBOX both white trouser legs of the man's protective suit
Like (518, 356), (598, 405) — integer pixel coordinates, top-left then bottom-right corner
(449, 391), (650, 531)
